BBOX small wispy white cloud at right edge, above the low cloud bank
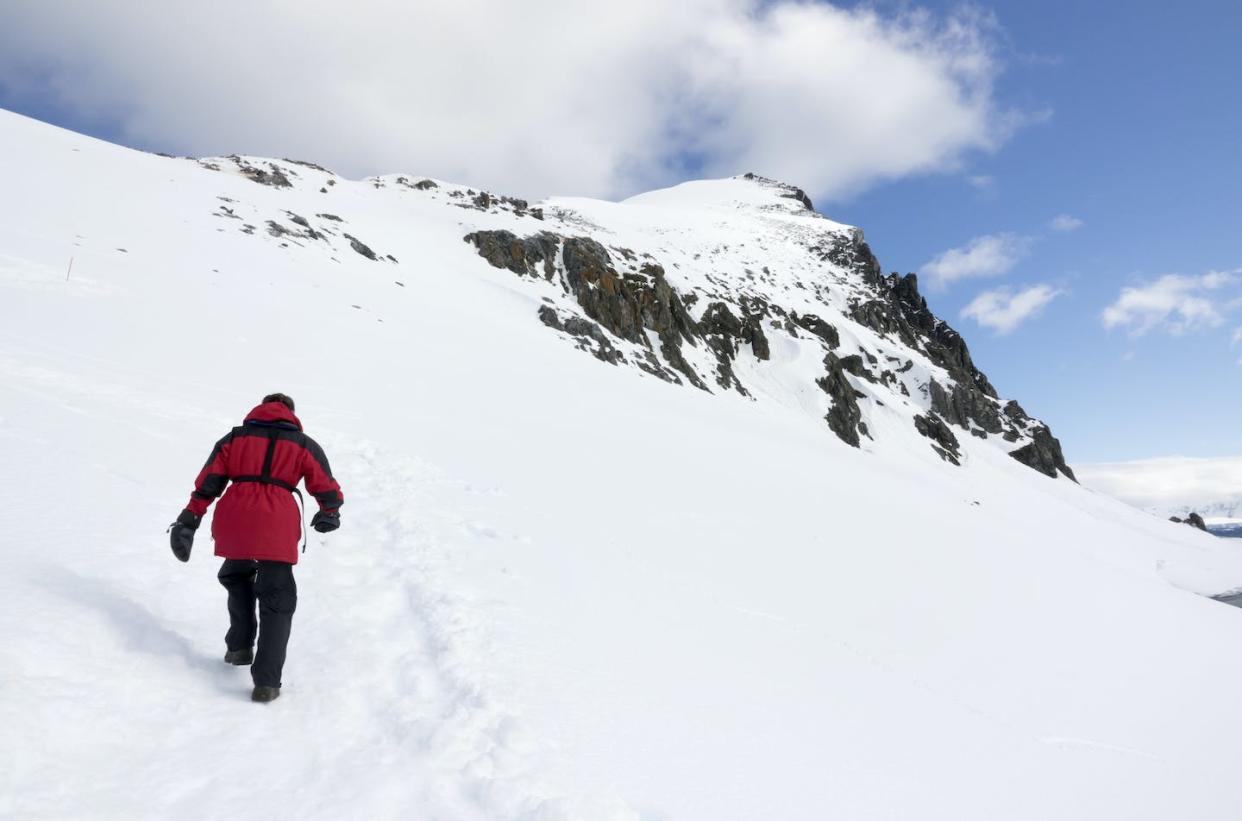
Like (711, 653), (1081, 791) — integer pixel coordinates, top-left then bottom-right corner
(1100, 270), (1242, 337)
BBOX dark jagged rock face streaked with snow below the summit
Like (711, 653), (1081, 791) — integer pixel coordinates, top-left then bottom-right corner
(448, 175), (1073, 478)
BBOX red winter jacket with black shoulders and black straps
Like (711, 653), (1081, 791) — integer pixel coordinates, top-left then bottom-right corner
(186, 402), (345, 564)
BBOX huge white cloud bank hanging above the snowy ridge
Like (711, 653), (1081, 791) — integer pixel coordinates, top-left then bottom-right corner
(0, 0), (1021, 197)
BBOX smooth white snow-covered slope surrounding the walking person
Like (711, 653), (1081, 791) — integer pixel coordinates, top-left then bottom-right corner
(0, 113), (1242, 820)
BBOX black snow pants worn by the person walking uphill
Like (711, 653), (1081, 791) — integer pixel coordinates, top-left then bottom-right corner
(217, 559), (298, 687)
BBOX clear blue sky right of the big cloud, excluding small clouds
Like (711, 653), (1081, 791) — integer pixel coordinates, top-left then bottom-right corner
(831, 0), (1242, 461)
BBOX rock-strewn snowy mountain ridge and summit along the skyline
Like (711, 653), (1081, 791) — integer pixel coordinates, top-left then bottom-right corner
(191, 156), (1073, 478)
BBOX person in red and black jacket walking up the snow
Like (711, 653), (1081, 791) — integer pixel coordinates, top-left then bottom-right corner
(169, 394), (345, 702)
